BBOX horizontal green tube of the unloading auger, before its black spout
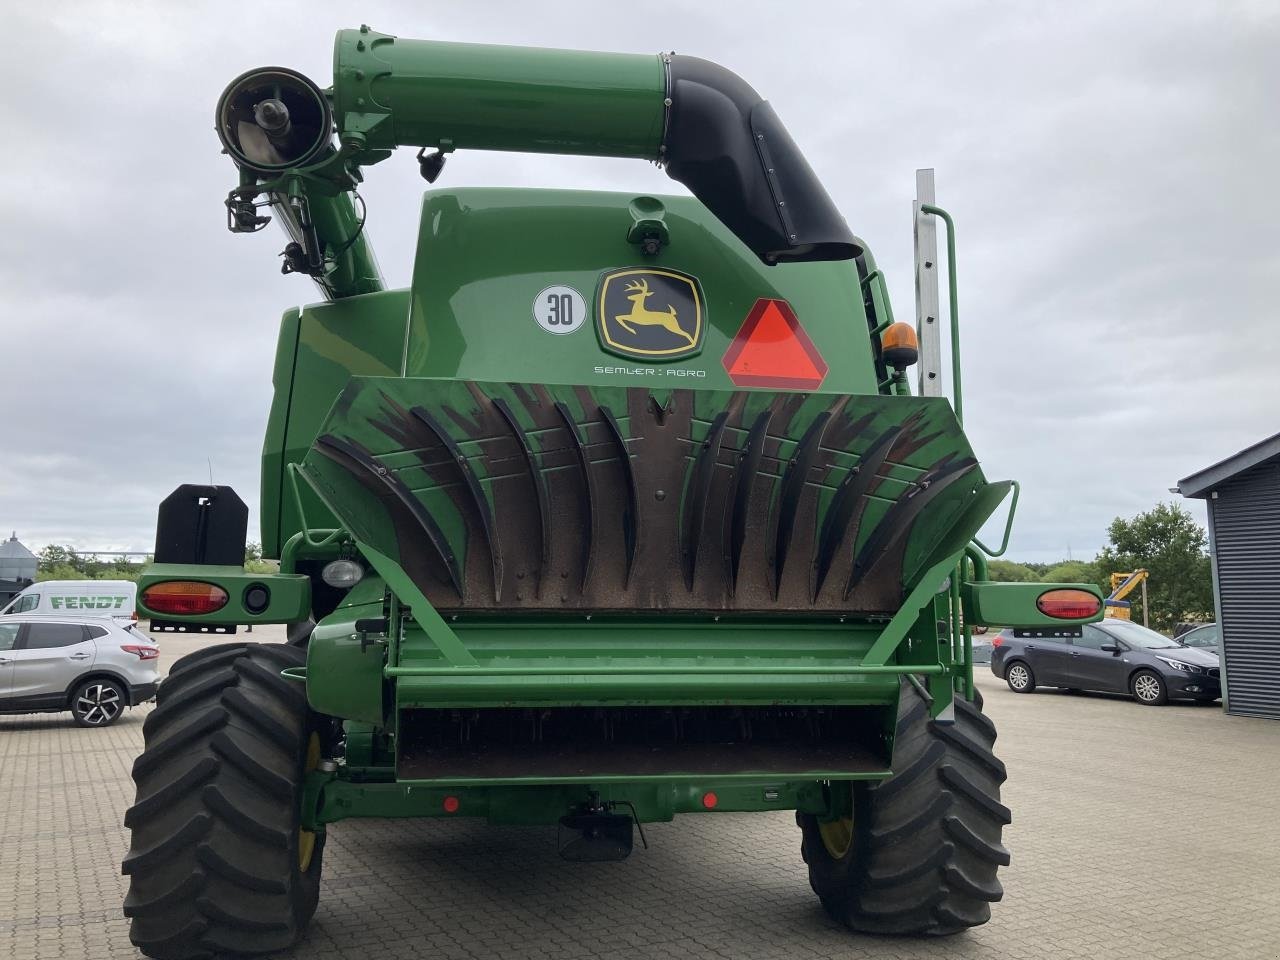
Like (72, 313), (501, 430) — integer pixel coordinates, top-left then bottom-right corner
(333, 28), (666, 160)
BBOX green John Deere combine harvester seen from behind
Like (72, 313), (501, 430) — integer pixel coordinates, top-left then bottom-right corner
(124, 27), (1102, 960)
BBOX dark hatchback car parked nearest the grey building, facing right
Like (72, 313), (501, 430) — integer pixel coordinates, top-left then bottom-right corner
(991, 617), (1222, 707)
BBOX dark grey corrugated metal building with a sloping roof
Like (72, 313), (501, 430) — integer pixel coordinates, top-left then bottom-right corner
(1176, 434), (1280, 719)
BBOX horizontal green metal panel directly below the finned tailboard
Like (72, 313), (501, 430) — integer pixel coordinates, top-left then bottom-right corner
(387, 618), (906, 709)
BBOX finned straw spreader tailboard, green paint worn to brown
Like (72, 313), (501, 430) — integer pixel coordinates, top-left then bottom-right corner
(296, 378), (1005, 616)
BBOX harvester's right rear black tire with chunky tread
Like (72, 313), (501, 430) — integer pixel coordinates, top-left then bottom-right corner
(796, 684), (1010, 936)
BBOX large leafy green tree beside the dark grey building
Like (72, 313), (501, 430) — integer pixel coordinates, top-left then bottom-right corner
(1097, 503), (1213, 632)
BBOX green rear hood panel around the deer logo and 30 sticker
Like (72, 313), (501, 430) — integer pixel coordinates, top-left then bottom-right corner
(404, 188), (878, 394)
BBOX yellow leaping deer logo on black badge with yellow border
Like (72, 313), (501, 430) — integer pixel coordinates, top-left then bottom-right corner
(596, 268), (703, 360)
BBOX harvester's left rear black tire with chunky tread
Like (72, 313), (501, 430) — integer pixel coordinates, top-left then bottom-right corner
(123, 643), (332, 960)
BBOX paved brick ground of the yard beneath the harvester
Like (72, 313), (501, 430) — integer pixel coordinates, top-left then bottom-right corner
(0, 635), (1280, 960)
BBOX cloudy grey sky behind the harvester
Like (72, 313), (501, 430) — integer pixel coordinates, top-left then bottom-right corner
(0, 0), (1280, 561)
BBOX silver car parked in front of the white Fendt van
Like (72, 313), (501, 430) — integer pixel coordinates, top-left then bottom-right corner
(0, 617), (160, 727)
